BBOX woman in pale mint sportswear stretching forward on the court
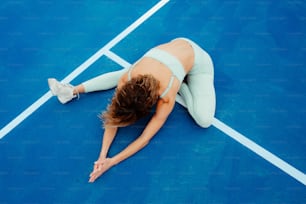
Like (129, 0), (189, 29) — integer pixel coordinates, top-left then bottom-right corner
(48, 38), (216, 182)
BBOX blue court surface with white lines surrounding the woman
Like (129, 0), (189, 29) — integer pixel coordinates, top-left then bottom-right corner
(0, 0), (306, 204)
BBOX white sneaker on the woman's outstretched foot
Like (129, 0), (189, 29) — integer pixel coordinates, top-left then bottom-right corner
(48, 78), (79, 104)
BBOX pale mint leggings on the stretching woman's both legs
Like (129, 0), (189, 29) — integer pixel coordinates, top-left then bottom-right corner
(83, 38), (216, 128)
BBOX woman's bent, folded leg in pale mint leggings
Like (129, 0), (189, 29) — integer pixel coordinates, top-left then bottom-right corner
(179, 38), (216, 128)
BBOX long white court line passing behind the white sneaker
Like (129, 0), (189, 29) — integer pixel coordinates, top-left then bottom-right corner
(0, 0), (169, 139)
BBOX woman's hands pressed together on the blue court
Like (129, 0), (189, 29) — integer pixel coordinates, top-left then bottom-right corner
(89, 158), (114, 183)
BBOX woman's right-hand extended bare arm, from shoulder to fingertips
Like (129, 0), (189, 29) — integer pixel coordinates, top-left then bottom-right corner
(89, 100), (175, 182)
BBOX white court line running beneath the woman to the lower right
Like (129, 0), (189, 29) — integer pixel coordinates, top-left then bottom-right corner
(106, 51), (306, 185)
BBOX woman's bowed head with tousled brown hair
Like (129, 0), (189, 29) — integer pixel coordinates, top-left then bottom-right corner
(102, 75), (159, 127)
